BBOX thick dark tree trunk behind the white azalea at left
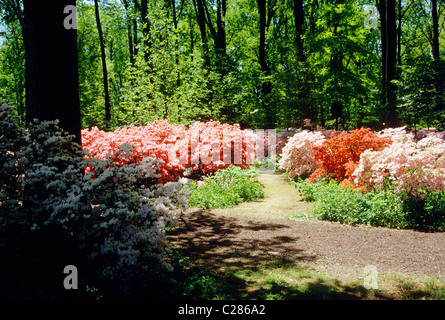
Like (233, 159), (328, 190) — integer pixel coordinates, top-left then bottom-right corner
(24, 0), (81, 143)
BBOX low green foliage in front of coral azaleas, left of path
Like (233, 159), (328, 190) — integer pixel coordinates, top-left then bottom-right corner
(185, 166), (264, 208)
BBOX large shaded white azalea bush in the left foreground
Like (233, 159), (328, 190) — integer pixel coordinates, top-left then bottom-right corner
(0, 104), (189, 288)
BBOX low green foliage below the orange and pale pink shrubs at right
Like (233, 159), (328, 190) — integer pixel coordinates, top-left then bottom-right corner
(292, 180), (445, 230)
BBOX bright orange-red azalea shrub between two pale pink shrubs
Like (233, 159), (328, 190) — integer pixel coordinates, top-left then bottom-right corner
(309, 128), (392, 182)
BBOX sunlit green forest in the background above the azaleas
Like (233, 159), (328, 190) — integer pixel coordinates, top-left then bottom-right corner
(0, 0), (445, 130)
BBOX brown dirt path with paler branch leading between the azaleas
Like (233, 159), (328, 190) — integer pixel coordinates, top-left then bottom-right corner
(171, 171), (445, 280)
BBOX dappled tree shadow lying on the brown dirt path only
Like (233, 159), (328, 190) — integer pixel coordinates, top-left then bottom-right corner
(169, 210), (315, 271)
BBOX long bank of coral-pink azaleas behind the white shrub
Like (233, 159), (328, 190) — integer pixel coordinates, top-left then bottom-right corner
(82, 119), (255, 183)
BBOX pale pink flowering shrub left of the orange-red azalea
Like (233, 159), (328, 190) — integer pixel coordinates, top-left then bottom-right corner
(278, 131), (325, 178)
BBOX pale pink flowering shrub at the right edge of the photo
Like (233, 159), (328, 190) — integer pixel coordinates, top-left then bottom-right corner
(353, 137), (445, 199)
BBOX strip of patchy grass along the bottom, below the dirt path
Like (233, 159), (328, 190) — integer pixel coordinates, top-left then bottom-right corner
(177, 258), (445, 300)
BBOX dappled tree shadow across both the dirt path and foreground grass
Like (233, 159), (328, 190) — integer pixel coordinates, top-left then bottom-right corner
(169, 210), (393, 300)
